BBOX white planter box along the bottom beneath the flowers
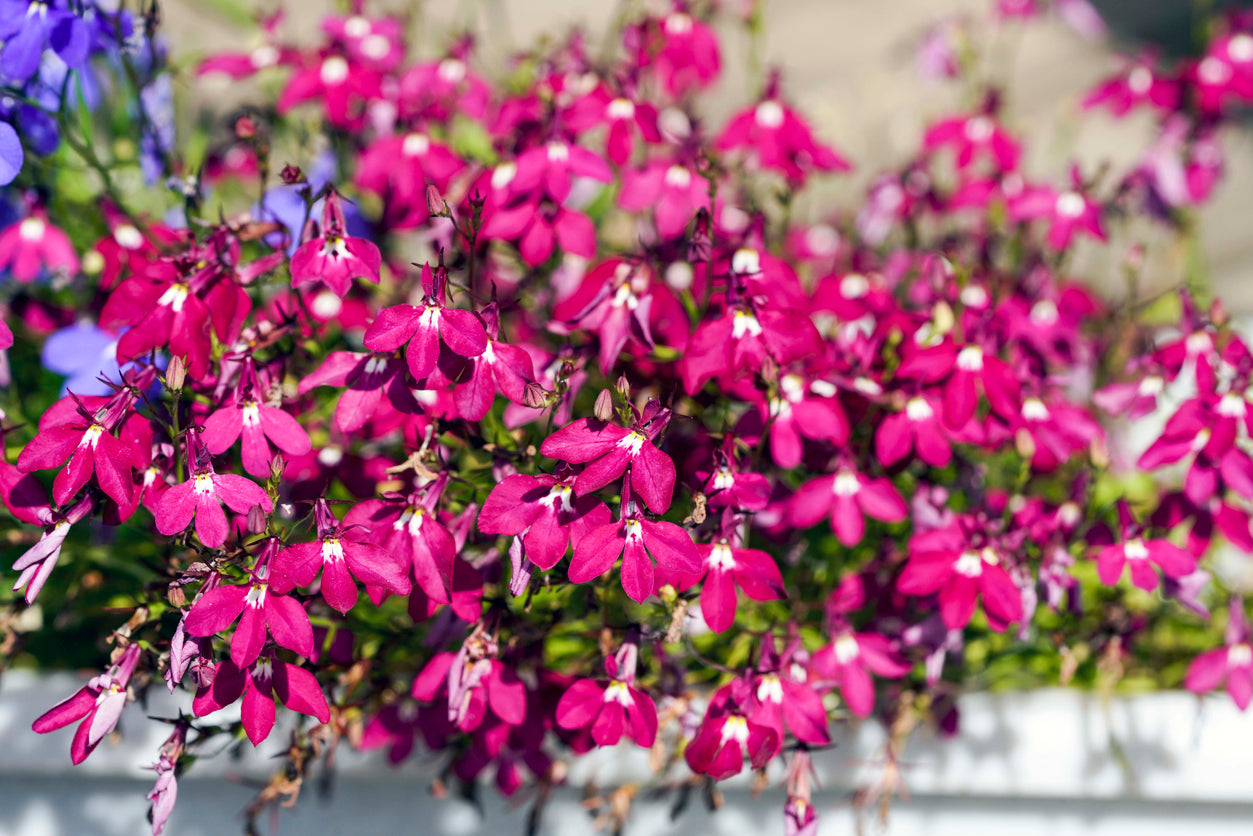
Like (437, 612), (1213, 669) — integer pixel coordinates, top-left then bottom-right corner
(0, 671), (1253, 836)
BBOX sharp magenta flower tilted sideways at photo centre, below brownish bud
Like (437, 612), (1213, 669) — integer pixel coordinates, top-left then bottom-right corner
(540, 400), (675, 513)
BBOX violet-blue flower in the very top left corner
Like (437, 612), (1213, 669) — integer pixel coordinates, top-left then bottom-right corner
(0, 0), (91, 83)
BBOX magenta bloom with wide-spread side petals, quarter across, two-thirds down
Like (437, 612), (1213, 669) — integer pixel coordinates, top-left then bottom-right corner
(269, 499), (412, 613)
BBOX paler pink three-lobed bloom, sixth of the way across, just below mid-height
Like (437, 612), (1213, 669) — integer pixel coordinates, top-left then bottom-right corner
(154, 430), (274, 549)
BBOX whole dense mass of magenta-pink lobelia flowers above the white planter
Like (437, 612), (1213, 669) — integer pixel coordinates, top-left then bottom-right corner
(7, 0), (1253, 833)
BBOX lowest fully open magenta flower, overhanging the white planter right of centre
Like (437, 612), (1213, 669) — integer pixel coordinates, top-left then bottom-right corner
(683, 678), (781, 781)
